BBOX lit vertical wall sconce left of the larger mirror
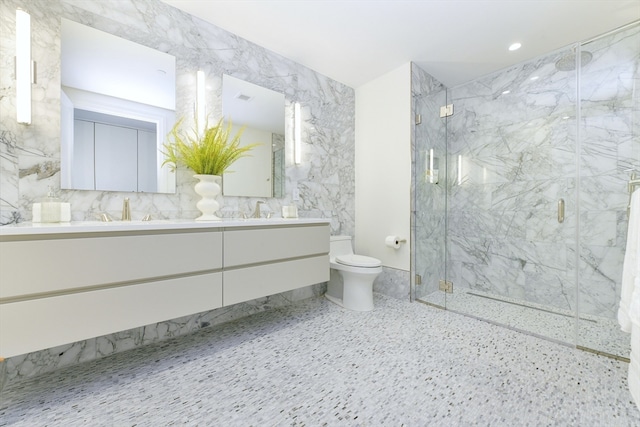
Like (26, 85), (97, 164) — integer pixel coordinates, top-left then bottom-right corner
(16, 9), (35, 125)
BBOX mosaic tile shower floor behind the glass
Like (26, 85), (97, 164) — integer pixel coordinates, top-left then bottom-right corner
(421, 290), (631, 359)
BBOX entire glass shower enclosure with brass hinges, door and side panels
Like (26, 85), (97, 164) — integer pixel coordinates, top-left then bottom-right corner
(412, 23), (640, 357)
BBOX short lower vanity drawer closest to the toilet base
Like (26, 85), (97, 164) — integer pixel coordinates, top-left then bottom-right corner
(223, 255), (329, 306)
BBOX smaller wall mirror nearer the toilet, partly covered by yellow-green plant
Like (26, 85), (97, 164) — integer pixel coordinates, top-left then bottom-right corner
(222, 75), (285, 197)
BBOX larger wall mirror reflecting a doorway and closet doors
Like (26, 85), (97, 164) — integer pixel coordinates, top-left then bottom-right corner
(60, 19), (176, 193)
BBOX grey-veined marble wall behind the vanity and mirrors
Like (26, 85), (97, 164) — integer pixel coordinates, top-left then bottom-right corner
(0, 0), (355, 383)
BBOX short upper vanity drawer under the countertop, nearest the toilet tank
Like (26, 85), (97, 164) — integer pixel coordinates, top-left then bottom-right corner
(224, 224), (329, 268)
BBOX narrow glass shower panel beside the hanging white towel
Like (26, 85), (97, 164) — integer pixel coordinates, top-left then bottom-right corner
(577, 24), (640, 357)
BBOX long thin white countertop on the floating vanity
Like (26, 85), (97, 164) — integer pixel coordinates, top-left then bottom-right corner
(0, 218), (330, 237)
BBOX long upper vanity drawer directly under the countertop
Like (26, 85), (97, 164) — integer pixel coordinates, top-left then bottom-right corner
(0, 232), (222, 301)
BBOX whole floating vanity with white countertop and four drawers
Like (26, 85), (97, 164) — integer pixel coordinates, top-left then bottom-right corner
(0, 219), (330, 358)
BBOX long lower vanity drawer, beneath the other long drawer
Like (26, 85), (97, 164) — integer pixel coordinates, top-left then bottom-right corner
(0, 272), (222, 357)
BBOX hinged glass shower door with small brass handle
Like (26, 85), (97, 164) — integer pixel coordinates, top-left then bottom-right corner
(446, 46), (577, 343)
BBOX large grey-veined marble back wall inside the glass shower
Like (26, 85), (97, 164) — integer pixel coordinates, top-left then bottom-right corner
(447, 21), (640, 318)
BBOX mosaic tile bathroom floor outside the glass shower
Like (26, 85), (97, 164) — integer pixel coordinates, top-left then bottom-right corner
(0, 295), (640, 427)
